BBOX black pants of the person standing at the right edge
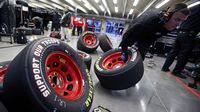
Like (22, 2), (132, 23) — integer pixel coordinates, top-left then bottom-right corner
(162, 32), (196, 73)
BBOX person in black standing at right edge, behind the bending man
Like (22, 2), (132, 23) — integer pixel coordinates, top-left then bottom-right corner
(161, 5), (200, 78)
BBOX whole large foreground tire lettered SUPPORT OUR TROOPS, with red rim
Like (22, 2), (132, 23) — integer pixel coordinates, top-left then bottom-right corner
(4, 38), (93, 112)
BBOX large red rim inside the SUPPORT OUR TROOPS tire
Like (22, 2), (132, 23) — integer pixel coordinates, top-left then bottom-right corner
(45, 52), (84, 100)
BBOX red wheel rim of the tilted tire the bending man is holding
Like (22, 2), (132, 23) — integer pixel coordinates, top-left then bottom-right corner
(102, 52), (130, 70)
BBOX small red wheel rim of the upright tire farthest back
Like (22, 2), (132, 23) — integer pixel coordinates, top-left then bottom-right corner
(83, 34), (97, 46)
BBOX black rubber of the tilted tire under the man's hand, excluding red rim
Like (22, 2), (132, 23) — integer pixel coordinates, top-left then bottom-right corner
(94, 48), (144, 90)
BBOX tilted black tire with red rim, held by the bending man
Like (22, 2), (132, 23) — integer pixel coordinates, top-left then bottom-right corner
(94, 48), (144, 90)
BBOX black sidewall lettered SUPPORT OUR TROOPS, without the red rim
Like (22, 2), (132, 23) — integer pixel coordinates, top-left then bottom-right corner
(19, 38), (93, 112)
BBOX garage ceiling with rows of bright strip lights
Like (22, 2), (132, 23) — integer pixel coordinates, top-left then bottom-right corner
(26, 0), (198, 19)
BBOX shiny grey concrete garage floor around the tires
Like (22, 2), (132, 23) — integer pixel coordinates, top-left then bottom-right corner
(0, 35), (200, 112)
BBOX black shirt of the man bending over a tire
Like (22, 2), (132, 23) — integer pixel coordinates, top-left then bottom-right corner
(120, 10), (168, 49)
